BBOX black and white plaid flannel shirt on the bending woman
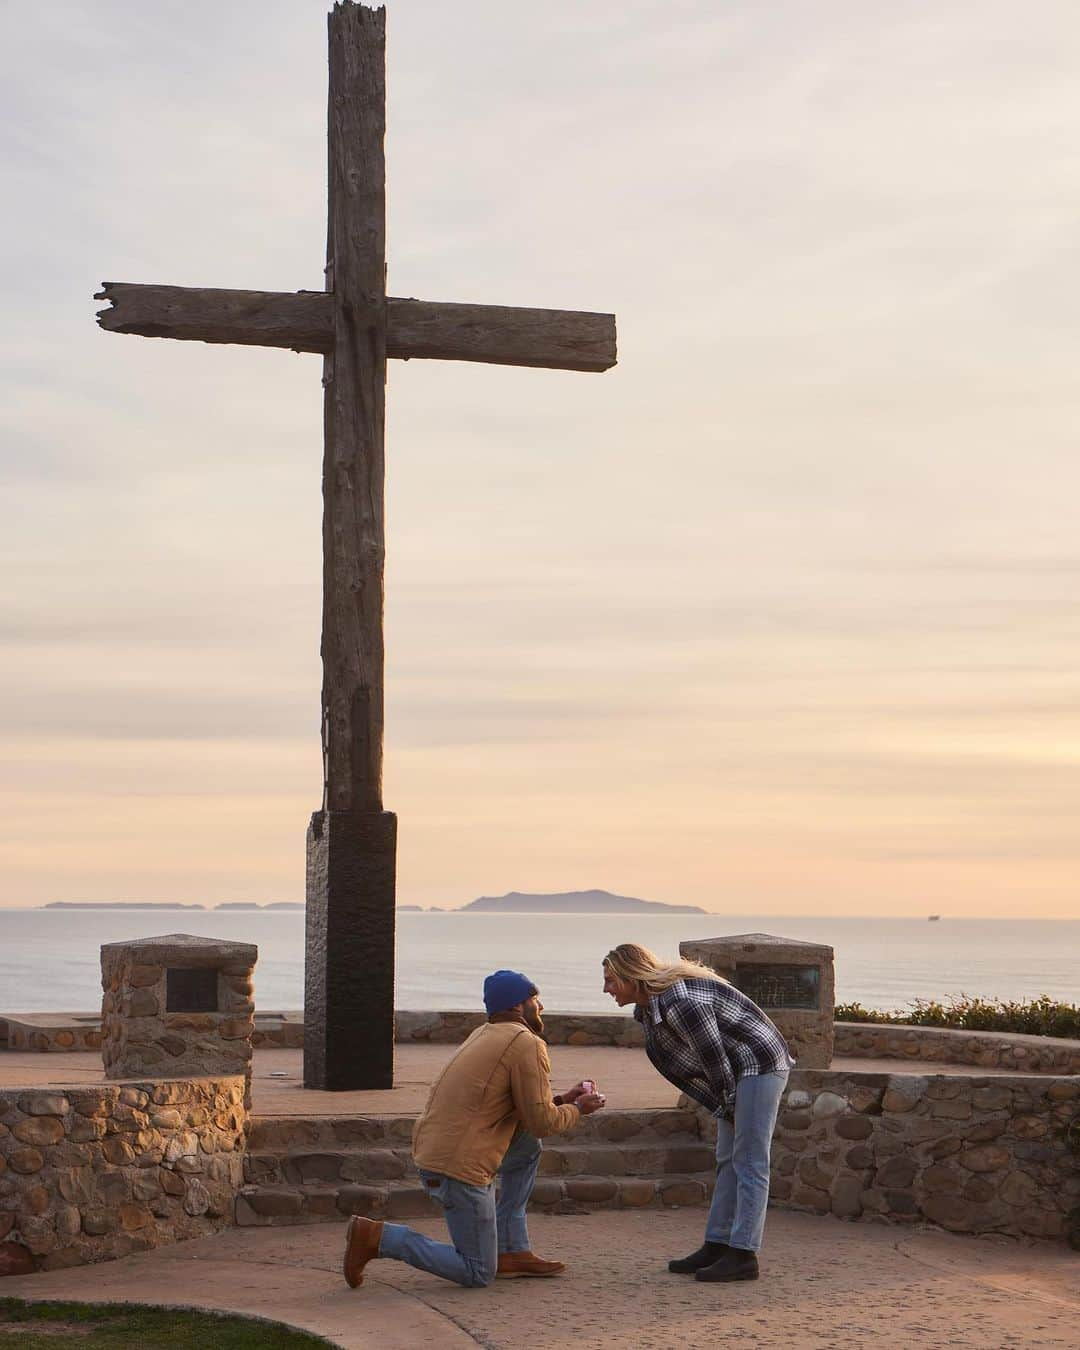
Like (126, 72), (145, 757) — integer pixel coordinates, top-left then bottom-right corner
(633, 980), (795, 1114)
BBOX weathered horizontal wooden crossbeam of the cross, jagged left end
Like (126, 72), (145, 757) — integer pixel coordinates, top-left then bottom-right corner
(95, 281), (616, 371)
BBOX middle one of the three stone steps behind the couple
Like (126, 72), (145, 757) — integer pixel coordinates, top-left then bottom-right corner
(244, 1134), (713, 1187)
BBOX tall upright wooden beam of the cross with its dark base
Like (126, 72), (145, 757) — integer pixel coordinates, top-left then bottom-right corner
(304, 4), (397, 1091)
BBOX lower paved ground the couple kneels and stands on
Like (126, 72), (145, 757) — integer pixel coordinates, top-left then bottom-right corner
(0, 1210), (1080, 1350)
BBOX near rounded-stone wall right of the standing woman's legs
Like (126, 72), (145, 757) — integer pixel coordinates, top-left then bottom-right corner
(702, 1069), (1080, 1241)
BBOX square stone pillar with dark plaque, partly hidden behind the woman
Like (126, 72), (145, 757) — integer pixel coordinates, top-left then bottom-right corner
(679, 933), (834, 1069)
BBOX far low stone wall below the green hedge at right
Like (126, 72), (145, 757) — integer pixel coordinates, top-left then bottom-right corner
(834, 1022), (1080, 1075)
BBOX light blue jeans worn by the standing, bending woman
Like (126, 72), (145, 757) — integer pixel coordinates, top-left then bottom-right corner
(705, 1072), (787, 1251)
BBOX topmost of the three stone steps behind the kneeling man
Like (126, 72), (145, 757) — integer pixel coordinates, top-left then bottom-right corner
(247, 1107), (698, 1152)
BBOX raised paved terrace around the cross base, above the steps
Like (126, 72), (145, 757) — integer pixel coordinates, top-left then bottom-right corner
(0, 1045), (1020, 1115)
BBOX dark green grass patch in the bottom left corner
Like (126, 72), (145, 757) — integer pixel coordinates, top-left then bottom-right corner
(0, 1299), (331, 1350)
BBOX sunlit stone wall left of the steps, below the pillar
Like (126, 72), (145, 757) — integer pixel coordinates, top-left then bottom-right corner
(0, 1075), (247, 1270)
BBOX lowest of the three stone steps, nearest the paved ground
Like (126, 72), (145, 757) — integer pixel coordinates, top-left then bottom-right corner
(236, 1170), (714, 1227)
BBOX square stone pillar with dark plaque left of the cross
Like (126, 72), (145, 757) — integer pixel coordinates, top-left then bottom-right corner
(101, 933), (259, 1079)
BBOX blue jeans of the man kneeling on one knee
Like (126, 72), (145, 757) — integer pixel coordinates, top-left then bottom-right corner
(379, 1131), (540, 1288)
